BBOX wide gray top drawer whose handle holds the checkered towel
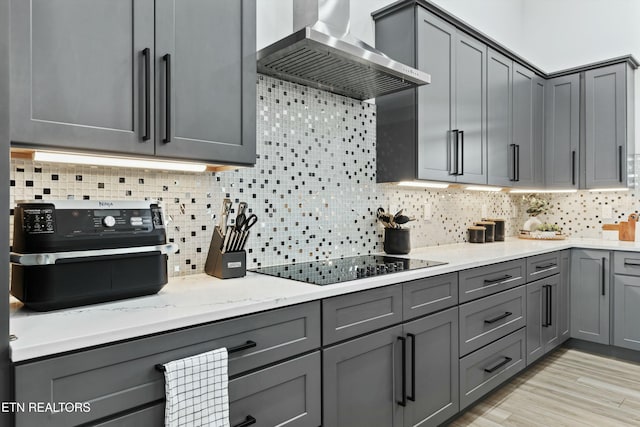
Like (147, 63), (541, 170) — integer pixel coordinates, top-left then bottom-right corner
(15, 302), (320, 427)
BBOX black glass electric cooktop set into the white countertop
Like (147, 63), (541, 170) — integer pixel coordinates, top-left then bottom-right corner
(251, 255), (446, 286)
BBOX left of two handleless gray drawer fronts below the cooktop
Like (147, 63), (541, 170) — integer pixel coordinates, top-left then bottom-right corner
(322, 285), (402, 345)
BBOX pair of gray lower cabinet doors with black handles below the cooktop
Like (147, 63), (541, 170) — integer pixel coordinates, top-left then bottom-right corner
(323, 308), (459, 427)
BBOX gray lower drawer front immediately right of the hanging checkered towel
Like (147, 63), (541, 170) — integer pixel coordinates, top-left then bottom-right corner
(229, 351), (322, 427)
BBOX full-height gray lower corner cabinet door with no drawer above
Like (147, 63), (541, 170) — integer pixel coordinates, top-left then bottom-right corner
(571, 250), (610, 344)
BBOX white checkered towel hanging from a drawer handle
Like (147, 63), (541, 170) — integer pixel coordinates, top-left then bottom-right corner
(164, 348), (229, 427)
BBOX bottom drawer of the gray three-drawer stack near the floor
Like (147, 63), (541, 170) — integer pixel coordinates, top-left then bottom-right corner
(460, 328), (526, 410)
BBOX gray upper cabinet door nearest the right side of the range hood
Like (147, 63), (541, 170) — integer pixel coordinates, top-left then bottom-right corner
(416, 8), (457, 181)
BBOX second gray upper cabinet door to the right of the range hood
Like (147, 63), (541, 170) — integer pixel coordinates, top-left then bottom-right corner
(454, 32), (487, 184)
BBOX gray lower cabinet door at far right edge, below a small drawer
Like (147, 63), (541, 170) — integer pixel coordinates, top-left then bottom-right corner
(613, 274), (640, 350)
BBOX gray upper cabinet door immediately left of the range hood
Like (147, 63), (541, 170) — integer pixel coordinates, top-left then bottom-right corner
(156, 0), (256, 164)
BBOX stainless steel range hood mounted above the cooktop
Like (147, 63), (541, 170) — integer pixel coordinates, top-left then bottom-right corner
(258, 0), (431, 100)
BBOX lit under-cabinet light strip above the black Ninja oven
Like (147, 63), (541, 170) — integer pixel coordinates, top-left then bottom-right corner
(33, 151), (207, 172)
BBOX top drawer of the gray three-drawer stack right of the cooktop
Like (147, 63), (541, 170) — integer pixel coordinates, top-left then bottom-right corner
(459, 258), (526, 303)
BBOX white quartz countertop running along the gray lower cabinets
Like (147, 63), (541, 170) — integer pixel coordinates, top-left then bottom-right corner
(10, 239), (640, 362)
